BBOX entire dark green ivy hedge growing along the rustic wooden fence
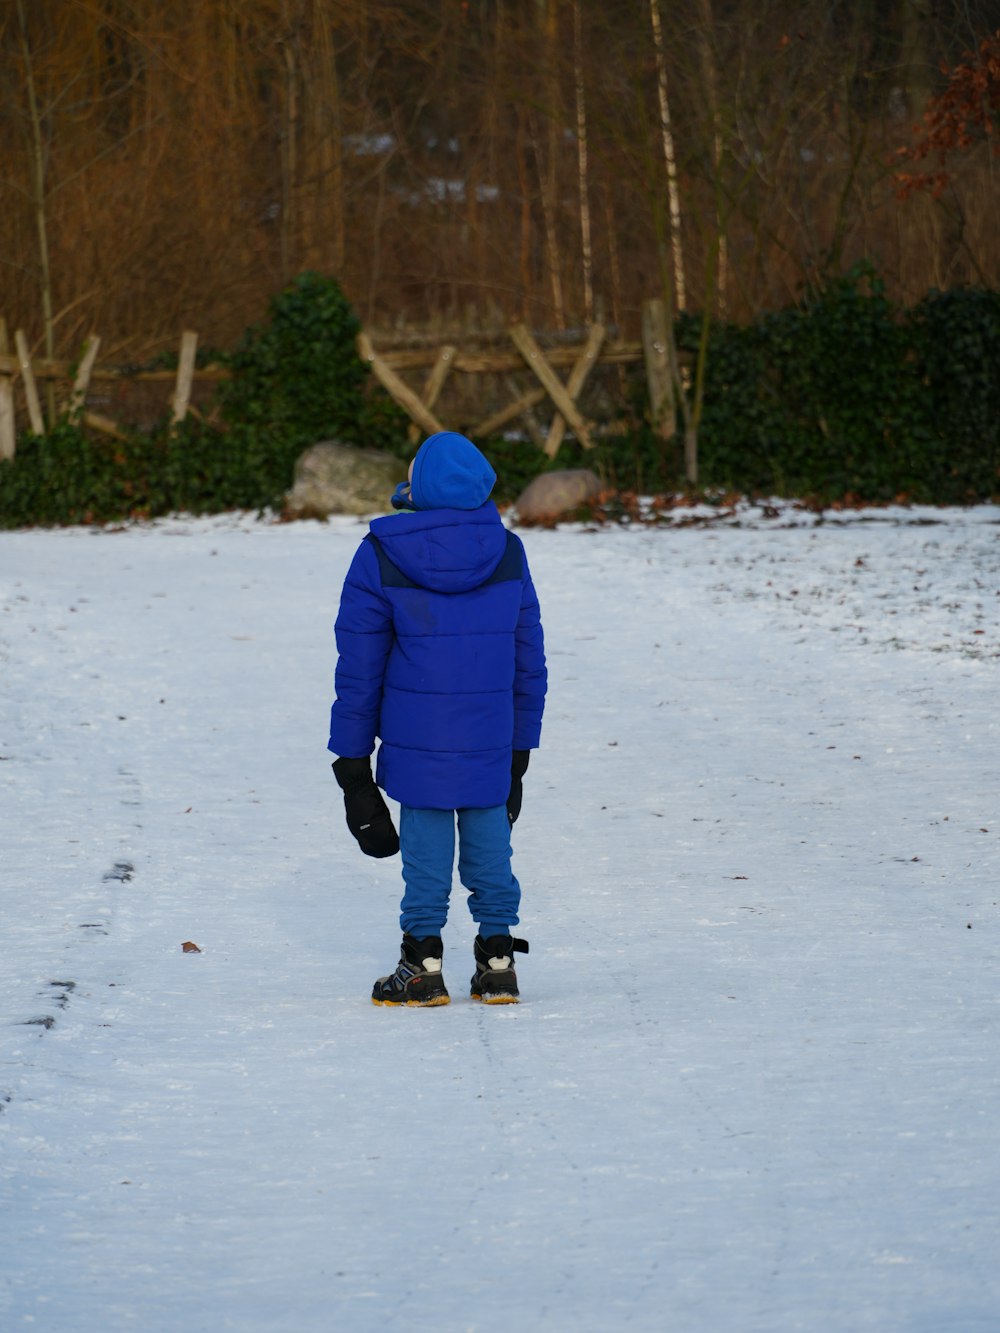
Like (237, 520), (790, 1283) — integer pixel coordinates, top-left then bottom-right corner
(0, 265), (1000, 528)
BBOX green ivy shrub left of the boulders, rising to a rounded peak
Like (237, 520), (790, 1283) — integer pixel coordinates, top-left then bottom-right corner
(0, 273), (405, 528)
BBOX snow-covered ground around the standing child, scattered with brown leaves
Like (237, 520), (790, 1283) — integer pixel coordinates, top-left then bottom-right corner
(0, 507), (1000, 1333)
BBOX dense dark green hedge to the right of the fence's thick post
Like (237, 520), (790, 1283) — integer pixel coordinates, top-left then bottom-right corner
(685, 269), (1000, 504)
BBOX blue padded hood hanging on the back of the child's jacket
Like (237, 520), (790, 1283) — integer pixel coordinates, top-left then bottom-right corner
(369, 501), (507, 592)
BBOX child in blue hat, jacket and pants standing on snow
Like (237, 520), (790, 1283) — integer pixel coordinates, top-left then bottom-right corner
(329, 431), (547, 1005)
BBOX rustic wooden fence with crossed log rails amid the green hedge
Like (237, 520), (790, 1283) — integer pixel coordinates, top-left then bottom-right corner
(0, 301), (688, 469)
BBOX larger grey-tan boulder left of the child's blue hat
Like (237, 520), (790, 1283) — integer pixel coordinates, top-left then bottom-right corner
(283, 440), (407, 519)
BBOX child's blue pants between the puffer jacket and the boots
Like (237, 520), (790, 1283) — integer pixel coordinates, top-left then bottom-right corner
(399, 805), (521, 940)
